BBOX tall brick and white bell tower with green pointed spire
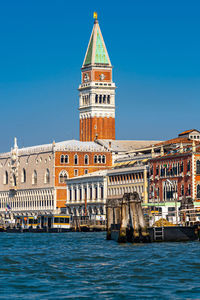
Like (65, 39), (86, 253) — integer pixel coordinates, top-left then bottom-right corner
(78, 13), (116, 141)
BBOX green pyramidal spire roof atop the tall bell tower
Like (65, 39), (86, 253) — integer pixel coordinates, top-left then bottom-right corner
(83, 21), (111, 67)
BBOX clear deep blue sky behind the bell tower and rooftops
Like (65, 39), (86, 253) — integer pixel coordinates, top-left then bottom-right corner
(0, 0), (200, 152)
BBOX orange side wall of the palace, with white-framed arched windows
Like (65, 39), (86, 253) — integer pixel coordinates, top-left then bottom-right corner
(55, 141), (112, 208)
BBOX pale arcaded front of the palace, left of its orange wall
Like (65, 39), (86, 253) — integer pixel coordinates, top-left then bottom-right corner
(0, 139), (56, 217)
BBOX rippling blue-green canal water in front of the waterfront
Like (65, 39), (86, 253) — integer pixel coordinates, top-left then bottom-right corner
(0, 232), (200, 299)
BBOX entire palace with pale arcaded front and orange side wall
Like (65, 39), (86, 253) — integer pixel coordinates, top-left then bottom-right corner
(0, 140), (112, 217)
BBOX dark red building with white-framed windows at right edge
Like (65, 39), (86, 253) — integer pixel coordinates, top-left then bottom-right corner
(149, 130), (200, 222)
